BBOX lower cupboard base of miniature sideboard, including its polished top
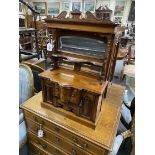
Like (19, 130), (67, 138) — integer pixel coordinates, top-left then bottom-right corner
(40, 69), (108, 128)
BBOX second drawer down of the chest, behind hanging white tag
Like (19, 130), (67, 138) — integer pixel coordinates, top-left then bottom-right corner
(27, 119), (90, 155)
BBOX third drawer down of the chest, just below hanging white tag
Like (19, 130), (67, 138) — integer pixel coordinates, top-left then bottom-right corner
(28, 132), (67, 155)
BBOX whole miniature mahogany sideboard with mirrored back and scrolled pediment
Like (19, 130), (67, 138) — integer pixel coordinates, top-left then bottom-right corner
(40, 10), (117, 128)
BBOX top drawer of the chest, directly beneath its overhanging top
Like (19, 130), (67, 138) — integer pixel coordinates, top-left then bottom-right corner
(25, 111), (105, 155)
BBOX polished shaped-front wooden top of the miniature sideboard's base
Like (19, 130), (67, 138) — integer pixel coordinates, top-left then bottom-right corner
(40, 68), (108, 94)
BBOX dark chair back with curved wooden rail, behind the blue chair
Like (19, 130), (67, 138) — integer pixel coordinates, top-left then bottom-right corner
(23, 62), (45, 93)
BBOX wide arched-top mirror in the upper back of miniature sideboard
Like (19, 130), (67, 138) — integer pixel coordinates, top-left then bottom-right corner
(58, 36), (107, 59)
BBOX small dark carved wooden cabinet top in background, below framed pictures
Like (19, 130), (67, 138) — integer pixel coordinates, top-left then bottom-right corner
(95, 6), (112, 20)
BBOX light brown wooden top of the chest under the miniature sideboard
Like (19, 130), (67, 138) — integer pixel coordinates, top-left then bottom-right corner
(21, 84), (124, 150)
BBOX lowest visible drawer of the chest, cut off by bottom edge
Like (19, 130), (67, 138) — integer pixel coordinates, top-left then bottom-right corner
(29, 142), (54, 155)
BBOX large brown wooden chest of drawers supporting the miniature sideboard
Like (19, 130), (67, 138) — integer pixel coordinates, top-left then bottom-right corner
(21, 84), (124, 155)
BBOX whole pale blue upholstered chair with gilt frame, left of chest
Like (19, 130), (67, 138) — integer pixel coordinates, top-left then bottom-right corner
(19, 64), (34, 149)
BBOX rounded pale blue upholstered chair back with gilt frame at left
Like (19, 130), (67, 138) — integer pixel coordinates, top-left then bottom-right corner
(19, 64), (34, 104)
